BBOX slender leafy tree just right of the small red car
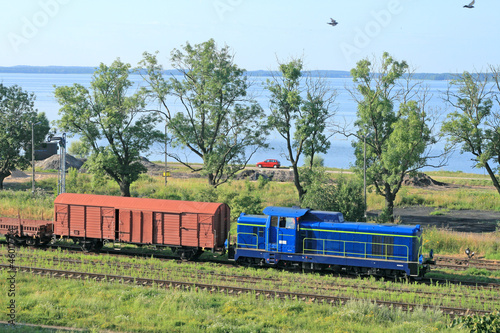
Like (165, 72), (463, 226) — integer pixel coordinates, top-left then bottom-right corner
(267, 59), (336, 200)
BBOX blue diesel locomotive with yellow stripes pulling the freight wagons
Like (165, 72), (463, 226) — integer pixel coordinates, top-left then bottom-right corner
(234, 207), (433, 277)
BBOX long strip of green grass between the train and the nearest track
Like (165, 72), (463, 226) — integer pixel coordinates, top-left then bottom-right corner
(2, 244), (498, 310)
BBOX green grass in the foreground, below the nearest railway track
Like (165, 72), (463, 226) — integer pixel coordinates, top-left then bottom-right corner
(0, 272), (458, 332)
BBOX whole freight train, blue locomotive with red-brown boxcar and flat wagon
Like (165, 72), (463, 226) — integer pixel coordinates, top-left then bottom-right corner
(0, 193), (434, 277)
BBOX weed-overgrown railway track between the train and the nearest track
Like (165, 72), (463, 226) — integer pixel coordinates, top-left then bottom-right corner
(1, 248), (500, 316)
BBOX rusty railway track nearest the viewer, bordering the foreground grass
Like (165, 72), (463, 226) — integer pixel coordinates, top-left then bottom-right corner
(0, 264), (490, 317)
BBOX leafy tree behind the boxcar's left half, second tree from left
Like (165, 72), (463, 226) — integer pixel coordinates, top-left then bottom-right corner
(55, 59), (165, 197)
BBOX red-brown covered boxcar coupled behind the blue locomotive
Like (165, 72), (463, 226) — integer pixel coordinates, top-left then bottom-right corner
(54, 193), (230, 255)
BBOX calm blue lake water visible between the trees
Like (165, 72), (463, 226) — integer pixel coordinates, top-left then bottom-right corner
(0, 73), (485, 174)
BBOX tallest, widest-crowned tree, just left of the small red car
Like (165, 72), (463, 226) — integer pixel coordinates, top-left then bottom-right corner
(140, 39), (268, 187)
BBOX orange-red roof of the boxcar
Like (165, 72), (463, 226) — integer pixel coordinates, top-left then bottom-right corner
(54, 193), (225, 214)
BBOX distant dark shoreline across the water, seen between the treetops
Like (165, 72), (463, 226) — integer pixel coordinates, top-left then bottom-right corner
(0, 66), (456, 80)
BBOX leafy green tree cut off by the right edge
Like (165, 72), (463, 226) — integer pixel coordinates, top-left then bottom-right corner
(441, 67), (500, 194)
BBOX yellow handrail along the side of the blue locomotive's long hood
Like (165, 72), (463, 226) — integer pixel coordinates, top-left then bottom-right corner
(302, 238), (410, 262)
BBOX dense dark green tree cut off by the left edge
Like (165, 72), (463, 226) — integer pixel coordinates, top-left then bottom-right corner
(0, 83), (50, 190)
